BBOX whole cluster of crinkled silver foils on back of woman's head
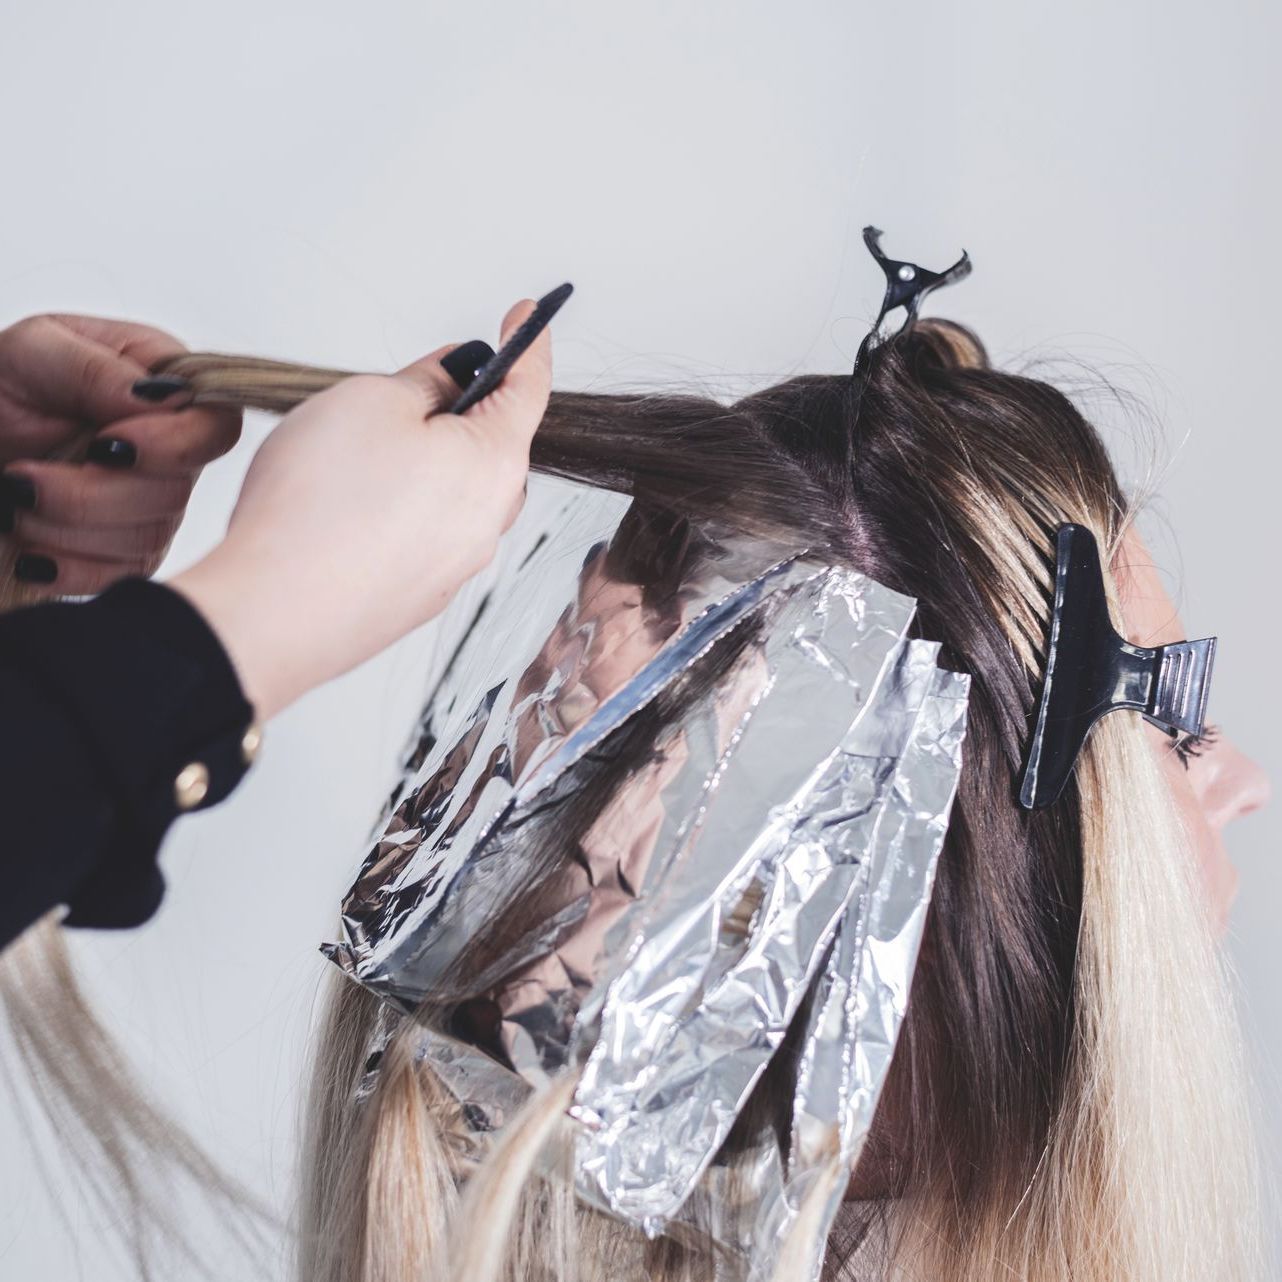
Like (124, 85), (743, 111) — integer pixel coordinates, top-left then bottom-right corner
(327, 482), (967, 1277)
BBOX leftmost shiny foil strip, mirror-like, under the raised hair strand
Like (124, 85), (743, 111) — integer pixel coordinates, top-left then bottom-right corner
(326, 496), (819, 1011)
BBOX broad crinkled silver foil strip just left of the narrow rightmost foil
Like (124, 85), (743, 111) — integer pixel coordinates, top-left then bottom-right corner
(573, 569), (936, 1232)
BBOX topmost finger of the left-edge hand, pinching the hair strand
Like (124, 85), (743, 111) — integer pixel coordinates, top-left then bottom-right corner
(0, 317), (185, 423)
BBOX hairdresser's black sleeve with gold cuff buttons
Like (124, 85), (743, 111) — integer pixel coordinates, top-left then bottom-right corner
(0, 579), (258, 947)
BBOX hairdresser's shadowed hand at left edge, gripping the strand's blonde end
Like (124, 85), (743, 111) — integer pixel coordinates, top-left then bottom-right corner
(0, 315), (240, 595)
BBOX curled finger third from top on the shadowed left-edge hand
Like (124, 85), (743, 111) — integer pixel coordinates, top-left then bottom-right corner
(4, 462), (194, 532)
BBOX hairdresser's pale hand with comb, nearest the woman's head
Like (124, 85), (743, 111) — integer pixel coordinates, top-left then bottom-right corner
(172, 301), (551, 718)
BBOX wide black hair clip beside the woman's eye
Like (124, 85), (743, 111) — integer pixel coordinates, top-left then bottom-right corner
(1019, 526), (1215, 810)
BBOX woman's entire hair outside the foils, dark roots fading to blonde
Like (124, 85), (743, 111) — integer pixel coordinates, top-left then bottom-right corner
(0, 322), (1260, 1282)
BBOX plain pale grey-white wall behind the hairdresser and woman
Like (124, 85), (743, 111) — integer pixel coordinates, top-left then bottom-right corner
(0, 0), (1282, 1282)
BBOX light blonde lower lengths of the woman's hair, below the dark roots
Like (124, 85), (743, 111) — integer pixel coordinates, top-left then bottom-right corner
(288, 718), (1261, 1282)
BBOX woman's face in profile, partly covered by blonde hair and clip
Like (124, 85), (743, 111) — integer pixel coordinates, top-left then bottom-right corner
(1113, 533), (1269, 931)
